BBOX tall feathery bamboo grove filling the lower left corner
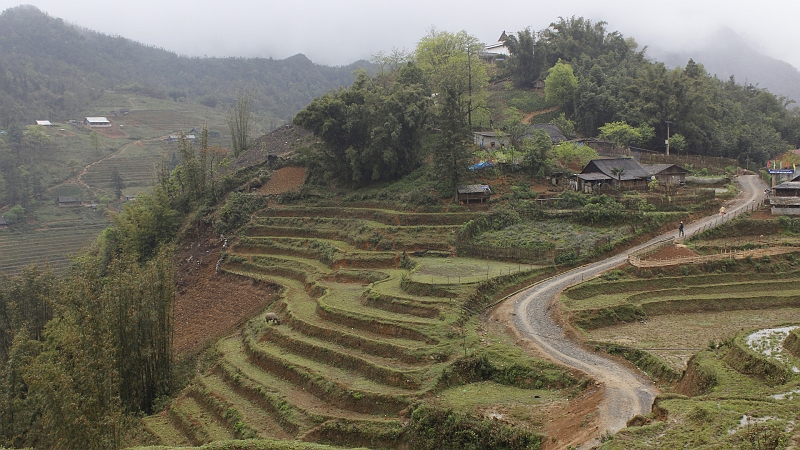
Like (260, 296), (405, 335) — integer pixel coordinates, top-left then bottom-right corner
(0, 207), (175, 449)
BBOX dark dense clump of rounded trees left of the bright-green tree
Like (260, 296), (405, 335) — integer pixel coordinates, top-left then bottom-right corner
(294, 64), (431, 185)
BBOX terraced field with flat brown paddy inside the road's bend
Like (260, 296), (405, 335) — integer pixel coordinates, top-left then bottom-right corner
(561, 271), (800, 371)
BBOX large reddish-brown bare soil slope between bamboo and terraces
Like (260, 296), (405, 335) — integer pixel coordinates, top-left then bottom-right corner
(173, 232), (279, 355)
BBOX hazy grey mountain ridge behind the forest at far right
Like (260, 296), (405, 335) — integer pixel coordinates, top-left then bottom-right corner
(647, 27), (800, 101)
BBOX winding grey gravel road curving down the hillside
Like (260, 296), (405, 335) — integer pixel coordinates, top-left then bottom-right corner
(508, 176), (765, 448)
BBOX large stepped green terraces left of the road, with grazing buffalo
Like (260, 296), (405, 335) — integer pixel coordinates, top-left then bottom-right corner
(145, 207), (538, 447)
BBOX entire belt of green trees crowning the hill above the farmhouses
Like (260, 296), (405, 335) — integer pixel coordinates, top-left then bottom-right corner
(294, 17), (800, 196)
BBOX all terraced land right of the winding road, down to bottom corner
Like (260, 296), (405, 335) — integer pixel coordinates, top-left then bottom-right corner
(561, 211), (800, 449)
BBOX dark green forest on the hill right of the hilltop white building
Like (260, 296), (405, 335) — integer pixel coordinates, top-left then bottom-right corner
(506, 17), (800, 162)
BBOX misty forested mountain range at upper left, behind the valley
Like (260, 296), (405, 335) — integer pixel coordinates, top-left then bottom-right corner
(0, 6), (369, 126)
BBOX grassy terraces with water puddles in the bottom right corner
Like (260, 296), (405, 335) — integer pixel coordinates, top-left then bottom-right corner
(603, 326), (800, 449)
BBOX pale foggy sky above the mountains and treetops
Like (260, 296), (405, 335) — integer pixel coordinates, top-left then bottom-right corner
(0, 0), (800, 67)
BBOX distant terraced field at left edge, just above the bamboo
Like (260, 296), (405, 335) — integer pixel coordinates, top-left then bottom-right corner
(0, 223), (108, 276)
